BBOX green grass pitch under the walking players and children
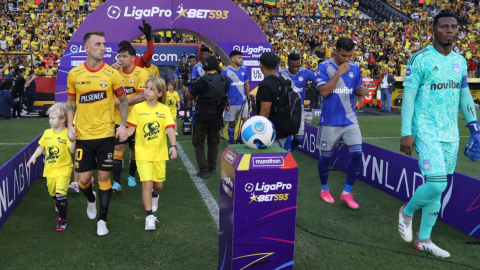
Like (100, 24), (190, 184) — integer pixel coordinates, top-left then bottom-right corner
(0, 111), (480, 270)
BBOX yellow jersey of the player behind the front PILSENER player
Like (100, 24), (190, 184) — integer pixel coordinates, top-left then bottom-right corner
(115, 66), (148, 125)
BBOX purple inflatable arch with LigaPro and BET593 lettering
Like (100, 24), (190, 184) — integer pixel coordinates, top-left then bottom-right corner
(55, 0), (272, 102)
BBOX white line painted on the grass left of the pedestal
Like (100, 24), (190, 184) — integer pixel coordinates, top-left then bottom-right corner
(177, 141), (219, 227)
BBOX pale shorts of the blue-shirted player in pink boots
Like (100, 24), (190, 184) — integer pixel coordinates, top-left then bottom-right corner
(316, 124), (362, 151)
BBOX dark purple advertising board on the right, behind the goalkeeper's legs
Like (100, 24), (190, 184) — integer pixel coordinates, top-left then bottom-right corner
(298, 125), (480, 239)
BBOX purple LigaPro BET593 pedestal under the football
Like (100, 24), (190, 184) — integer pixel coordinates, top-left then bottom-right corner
(218, 145), (298, 270)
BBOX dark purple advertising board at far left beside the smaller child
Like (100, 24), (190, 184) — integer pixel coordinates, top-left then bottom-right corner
(0, 134), (45, 228)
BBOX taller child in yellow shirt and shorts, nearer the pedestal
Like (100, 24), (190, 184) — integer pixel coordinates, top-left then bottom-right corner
(127, 77), (177, 231)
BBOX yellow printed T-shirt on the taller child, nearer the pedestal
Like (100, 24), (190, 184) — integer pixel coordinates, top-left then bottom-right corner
(127, 101), (175, 161)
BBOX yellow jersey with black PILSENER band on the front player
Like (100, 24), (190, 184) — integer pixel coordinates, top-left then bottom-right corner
(67, 63), (125, 140)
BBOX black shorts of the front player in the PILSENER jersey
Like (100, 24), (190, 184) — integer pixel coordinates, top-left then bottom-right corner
(75, 137), (115, 173)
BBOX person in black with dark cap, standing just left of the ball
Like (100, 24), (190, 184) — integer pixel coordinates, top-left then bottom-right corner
(183, 56), (230, 178)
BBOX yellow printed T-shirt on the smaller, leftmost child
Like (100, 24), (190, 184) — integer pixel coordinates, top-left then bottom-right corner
(38, 128), (73, 177)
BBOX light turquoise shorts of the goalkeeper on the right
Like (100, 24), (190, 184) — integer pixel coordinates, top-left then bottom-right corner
(415, 138), (459, 176)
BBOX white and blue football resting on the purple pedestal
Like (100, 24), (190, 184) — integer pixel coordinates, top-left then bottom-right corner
(242, 116), (275, 149)
